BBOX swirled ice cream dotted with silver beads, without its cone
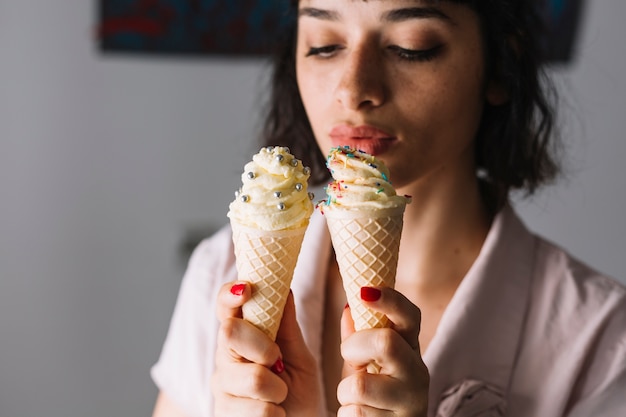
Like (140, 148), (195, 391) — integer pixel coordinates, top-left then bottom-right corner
(228, 147), (313, 231)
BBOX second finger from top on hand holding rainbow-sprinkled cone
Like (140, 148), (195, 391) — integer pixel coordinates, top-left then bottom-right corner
(341, 328), (423, 380)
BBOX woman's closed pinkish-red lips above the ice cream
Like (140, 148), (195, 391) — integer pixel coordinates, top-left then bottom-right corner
(329, 124), (397, 156)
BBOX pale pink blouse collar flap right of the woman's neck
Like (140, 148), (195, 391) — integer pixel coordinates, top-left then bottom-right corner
(424, 206), (535, 407)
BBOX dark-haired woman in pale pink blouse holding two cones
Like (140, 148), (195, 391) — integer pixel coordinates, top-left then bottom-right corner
(153, 0), (626, 417)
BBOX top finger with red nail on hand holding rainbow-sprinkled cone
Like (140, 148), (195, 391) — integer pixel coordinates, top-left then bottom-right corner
(361, 287), (422, 352)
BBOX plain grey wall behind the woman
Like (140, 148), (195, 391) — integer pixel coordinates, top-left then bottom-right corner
(0, 0), (626, 417)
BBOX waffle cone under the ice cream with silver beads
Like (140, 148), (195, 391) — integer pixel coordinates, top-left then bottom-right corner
(231, 222), (306, 340)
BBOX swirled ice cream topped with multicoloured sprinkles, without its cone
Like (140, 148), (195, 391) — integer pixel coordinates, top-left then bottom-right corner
(318, 147), (411, 212)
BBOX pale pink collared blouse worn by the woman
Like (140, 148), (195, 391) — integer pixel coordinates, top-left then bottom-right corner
(152, 207), (626, 417)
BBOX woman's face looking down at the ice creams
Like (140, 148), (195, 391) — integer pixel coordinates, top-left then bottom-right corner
(296, 0), (494, 187)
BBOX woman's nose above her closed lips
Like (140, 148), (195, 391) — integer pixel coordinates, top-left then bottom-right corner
(335, 43), (386, 110)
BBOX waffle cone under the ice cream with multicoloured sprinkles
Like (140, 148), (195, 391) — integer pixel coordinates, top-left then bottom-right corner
(324, 207), (404, 330)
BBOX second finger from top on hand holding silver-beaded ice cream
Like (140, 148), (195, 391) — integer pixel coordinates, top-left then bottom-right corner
(216, 317), (281, 367)
